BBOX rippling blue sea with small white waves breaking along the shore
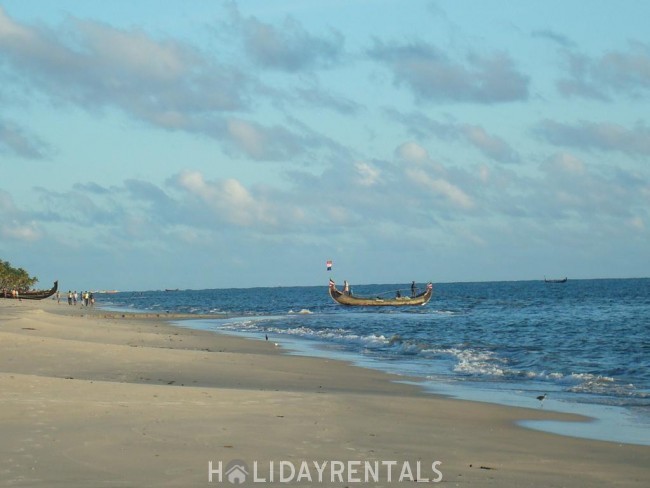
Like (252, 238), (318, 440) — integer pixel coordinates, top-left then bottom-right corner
(96, 278), (650, 445)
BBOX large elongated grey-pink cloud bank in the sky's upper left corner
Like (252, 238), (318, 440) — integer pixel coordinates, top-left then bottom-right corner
(0, 7), (249, 131)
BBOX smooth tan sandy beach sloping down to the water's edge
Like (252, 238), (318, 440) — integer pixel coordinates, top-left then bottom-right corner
(0, 299), (650, 487)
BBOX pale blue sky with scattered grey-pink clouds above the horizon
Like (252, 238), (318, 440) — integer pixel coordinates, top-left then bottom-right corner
(0, 0), (650, 291)
